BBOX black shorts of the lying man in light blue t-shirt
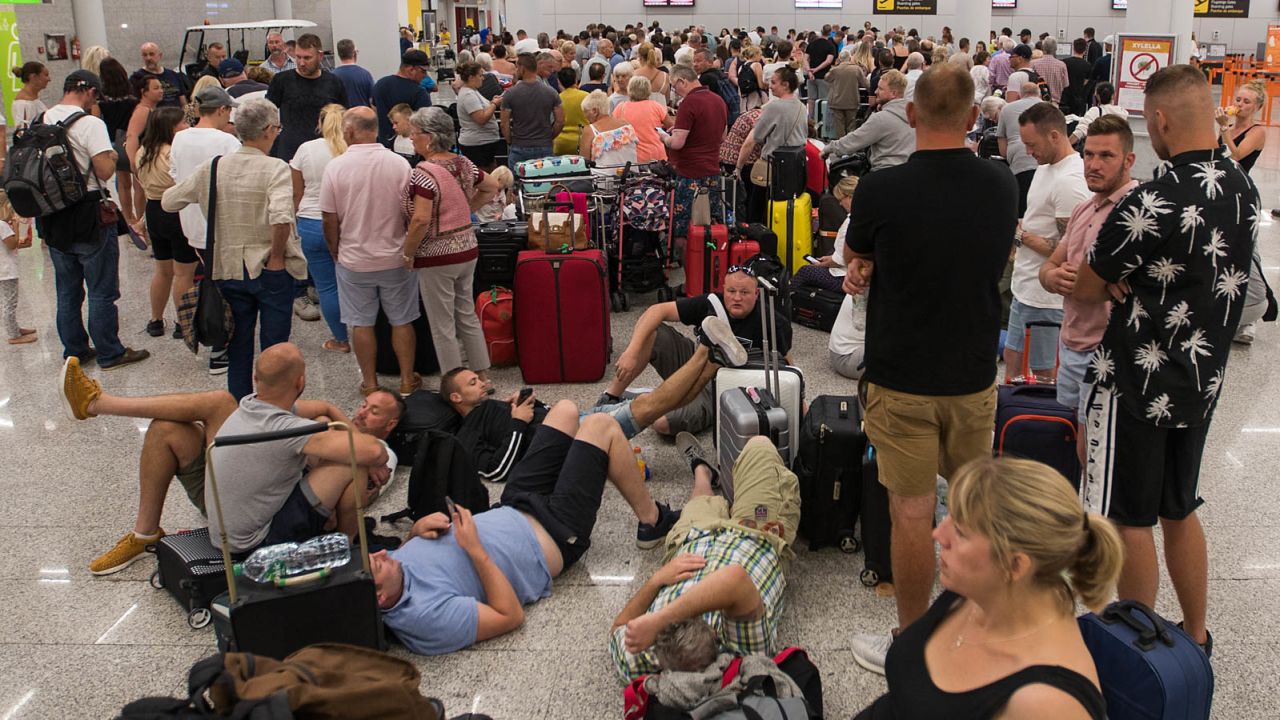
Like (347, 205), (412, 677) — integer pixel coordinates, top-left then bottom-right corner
(502, 425), (609, 569)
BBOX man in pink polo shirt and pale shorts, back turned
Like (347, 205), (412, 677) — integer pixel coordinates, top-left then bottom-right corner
(320, 106), (422, 395)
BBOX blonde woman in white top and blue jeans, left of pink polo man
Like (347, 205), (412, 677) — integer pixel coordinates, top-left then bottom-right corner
(289, 102), (350, 352)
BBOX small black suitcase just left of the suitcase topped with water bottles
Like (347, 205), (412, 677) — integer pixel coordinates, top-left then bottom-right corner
(147, 528), (227, 630)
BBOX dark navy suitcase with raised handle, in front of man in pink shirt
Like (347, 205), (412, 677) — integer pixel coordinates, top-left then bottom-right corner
(992, 322), (1080, 489)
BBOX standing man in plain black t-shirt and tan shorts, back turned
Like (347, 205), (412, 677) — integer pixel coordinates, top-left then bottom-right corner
(845, 63), (1018, 673)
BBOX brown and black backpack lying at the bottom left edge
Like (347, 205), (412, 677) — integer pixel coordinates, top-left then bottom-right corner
(120, 643), (444, 720)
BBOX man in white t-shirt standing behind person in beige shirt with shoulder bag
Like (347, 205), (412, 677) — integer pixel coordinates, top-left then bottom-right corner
(169, 87), (239, 375)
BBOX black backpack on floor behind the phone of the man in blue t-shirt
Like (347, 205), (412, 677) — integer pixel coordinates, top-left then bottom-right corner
(383, 430), (489, 523)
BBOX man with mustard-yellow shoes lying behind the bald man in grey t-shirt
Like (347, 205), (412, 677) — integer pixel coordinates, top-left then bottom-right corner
(59, 340), (403, 575)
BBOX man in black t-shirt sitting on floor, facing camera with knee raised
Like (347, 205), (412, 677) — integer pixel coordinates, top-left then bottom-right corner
(598, 269), (788, 436)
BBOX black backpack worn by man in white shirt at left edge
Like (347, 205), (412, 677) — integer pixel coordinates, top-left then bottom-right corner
(0, 111), (88, 218)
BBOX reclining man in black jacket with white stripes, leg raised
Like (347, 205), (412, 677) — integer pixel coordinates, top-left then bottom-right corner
(440, 315), (754, 482)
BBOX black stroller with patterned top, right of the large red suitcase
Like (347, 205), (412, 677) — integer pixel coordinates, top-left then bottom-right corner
(608, 163), (676, 313)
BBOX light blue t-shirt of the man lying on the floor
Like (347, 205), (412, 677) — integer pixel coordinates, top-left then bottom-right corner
(384, 507), (552, 655)
